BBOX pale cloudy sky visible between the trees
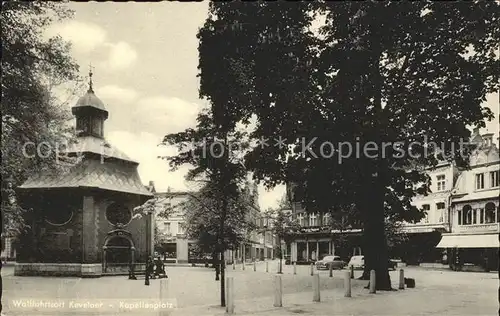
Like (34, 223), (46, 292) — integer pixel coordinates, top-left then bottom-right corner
(48, 1), (499, 209)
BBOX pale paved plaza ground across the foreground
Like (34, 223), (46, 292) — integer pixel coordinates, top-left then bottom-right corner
(2, 261), (499, 316)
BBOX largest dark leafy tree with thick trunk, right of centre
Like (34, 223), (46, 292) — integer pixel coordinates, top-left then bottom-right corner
(199, 1), (500, 290)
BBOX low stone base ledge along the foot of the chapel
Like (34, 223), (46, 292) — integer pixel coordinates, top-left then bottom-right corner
(14, 262), (102, 278)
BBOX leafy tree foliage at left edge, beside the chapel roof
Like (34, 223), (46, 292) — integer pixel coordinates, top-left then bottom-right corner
(1, 1), (80, 236)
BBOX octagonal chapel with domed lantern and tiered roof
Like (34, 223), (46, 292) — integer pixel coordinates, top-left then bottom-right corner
(15, 73), (154, 277)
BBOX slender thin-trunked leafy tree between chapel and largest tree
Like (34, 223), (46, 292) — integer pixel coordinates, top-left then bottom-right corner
(163, 106), (252, 306)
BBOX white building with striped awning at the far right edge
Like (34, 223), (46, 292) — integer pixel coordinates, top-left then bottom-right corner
(438, 130), (500, 271)
